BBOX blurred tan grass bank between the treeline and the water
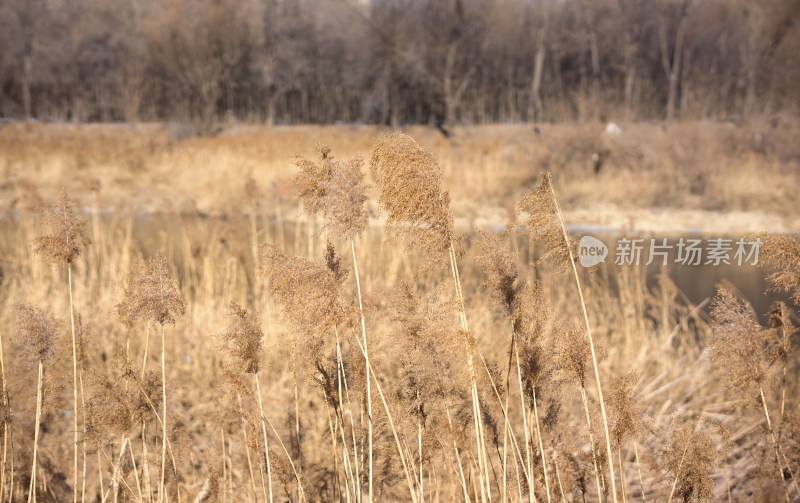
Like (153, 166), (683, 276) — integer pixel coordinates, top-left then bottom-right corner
(0, 119), (800, 232)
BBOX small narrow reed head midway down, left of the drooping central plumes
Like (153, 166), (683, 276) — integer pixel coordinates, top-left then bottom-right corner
(219, 302), (264, 374)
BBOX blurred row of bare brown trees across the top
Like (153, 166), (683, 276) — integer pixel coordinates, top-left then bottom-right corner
(0, 0), (800, 125)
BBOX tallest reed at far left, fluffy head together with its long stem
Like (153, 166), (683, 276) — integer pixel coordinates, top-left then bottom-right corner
(34, 190), (91, 503)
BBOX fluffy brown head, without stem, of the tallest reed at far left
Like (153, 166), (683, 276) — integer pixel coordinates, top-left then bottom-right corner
(34, 191), (91, 264)
